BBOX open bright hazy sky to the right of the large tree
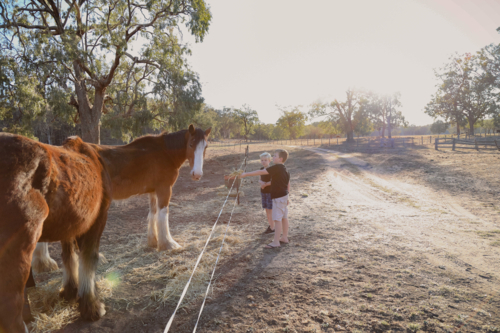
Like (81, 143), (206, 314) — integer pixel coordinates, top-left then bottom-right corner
(184, 0), (500, 125)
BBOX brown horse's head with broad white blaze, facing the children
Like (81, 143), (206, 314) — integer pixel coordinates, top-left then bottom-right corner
(186, 125), (212, 180)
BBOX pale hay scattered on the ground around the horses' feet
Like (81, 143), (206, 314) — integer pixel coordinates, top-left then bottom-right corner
(28, 219), (248, 333)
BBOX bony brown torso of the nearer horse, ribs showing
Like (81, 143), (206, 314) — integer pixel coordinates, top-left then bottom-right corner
(0, 134), (110, 241)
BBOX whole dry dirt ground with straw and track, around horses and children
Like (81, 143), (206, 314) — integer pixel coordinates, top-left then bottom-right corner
(28, 146), (500, 333)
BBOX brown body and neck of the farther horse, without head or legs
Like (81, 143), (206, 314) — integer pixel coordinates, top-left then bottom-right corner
(100, 138), (186, 199)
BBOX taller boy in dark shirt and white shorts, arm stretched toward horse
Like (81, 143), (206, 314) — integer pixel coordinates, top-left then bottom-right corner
(240, 149), (290, 249)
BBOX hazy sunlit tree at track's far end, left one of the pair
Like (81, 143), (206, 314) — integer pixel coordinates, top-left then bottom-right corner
(309, 89), (365, 141)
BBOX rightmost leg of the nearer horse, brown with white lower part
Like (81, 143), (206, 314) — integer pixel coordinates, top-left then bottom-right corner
(77, 199), (109, 321)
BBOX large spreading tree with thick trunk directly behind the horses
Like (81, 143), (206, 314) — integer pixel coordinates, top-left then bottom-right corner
(0, 0), (211, 143)
